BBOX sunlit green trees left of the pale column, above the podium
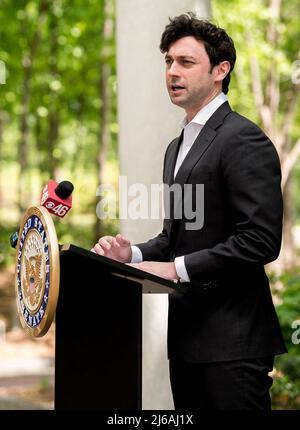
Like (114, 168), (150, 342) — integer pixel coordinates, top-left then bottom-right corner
(0, 0), (118, 264)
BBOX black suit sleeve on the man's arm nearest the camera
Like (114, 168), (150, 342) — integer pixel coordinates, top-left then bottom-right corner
(185, 124), (282, 281)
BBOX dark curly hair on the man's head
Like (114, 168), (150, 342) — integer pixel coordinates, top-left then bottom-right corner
(159, 12), (236, 94)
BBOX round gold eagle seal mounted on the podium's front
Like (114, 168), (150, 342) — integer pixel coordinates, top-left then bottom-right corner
(15, 206), (59, 337)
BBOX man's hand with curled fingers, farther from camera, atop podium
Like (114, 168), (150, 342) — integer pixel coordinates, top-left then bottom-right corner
(91, 234), (132, 263)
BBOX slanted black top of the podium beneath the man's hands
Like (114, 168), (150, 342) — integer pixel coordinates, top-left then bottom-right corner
(60, 244), (187, 294)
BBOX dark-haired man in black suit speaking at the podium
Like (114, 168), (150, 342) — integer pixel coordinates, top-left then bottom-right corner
(93, 14), (286, 410)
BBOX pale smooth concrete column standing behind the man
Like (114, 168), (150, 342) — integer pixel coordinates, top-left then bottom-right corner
(117, 0), (210, 409)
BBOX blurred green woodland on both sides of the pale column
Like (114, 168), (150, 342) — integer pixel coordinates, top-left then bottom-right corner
(0, 0), (300, 409)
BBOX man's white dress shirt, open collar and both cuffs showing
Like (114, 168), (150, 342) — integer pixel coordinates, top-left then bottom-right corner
(131, 93), (227, 282)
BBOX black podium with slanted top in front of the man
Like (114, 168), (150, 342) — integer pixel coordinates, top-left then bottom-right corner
(55, 245), (185, 410)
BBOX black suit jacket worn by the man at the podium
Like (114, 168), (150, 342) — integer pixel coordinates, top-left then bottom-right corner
(138, 102), (286, 362)
